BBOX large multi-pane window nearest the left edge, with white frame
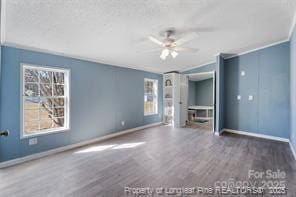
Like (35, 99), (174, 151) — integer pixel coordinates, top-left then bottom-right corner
(21, 65), (69, 137)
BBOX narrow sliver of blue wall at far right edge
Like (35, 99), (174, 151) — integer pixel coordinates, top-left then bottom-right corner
(290, 25), (296, 150)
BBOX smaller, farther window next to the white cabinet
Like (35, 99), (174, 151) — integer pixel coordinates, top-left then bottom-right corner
(144, 79), (158, 116)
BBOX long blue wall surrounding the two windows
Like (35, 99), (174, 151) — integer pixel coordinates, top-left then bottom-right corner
(0, 47), (162, 161)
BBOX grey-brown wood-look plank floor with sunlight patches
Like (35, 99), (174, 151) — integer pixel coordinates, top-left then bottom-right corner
(0, 126), (296, 197)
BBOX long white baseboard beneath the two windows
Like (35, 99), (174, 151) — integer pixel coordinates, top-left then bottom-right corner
(0, 122), (162, 168)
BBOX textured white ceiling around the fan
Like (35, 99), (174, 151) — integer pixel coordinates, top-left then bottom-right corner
(1, 0), (296, 72)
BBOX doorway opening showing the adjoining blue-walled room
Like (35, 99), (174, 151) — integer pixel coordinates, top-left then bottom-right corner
(187, 71), (215, 132)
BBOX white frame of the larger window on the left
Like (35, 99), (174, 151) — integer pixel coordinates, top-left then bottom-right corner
(20, 63), (71, 139)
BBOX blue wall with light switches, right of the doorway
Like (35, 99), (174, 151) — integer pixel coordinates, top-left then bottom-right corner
(224, 42), (290, 138)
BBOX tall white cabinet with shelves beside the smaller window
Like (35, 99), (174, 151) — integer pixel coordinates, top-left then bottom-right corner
(163, 73), (180, 127)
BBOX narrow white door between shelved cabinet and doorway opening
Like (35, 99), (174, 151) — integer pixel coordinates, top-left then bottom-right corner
(179, 74), (188, 127)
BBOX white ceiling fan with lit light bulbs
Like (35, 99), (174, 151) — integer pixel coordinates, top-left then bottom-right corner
(148, 29), (198, 60)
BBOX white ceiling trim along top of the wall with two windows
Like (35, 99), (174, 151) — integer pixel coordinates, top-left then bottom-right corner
(2, 42), (163, 74)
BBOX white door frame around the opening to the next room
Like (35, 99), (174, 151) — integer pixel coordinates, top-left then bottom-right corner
(185, 70), (216, 133)
